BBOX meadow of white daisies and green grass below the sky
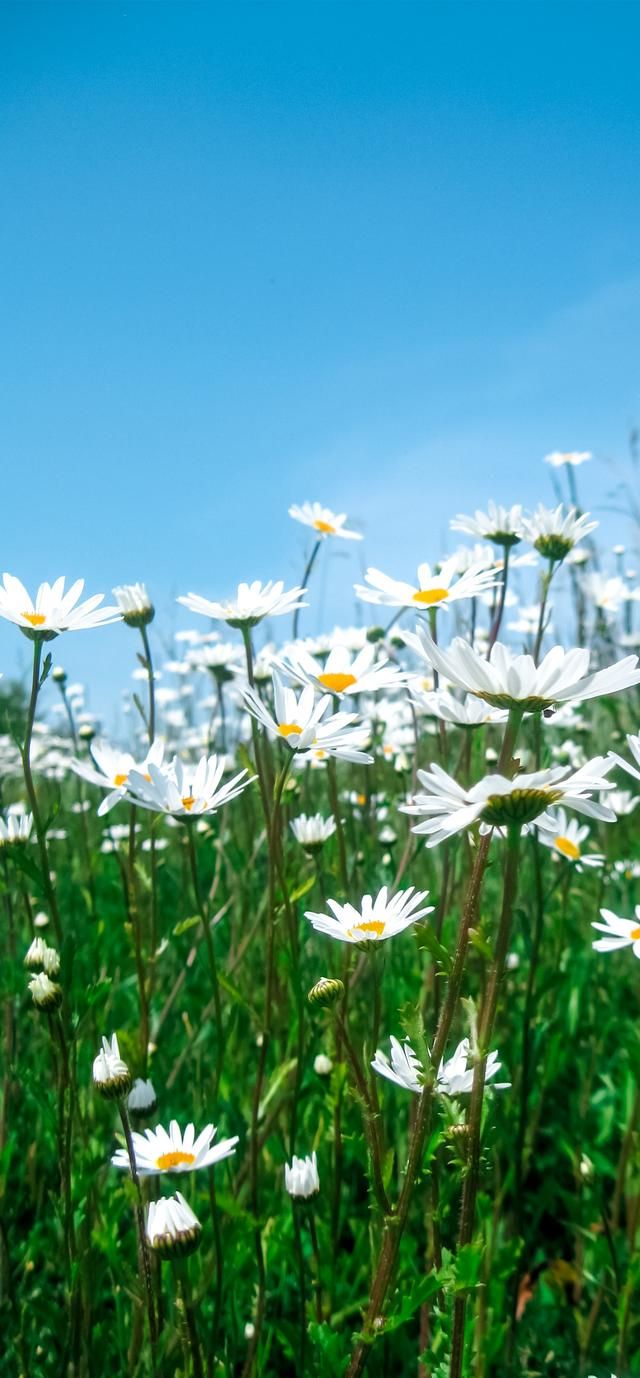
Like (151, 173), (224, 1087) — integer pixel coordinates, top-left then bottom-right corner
(0, 452), (640, 1378)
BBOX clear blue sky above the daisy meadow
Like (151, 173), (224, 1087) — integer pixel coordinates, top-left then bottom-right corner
(0, 0), (640, 707)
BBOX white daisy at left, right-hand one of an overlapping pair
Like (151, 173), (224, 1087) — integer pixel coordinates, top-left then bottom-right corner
(127, 755), (255, 819)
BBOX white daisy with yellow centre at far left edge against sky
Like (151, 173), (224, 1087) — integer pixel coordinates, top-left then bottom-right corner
(0, 575), (121, 641)
